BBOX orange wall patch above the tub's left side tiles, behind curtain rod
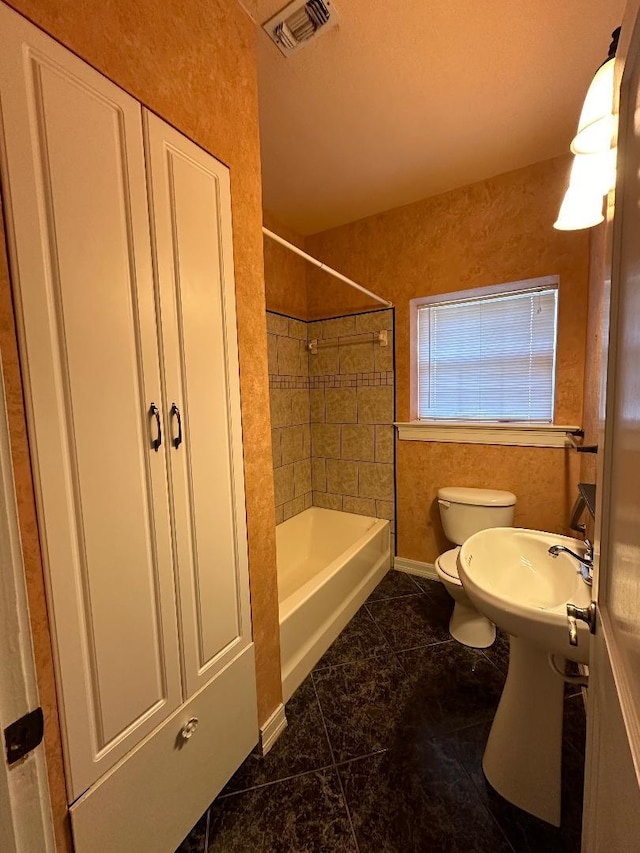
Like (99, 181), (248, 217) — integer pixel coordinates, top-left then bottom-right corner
(264, 211), (309, 320)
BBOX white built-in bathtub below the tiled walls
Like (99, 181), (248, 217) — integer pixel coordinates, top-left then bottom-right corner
(276, 507), (391, 702)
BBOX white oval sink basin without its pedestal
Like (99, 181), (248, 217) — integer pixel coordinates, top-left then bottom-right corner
(458, 527), (591, 663)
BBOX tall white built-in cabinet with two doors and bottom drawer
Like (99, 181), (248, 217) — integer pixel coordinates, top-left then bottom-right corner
(0, 4), (258, 853)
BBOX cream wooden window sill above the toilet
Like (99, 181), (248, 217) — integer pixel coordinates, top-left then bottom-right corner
(394, 421), (579, 448)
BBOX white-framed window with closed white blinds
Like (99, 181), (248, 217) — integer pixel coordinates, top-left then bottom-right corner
(414, 276), (558, 423)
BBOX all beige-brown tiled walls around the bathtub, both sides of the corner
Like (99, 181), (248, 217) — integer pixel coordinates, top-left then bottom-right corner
(267, 310), (394, 544)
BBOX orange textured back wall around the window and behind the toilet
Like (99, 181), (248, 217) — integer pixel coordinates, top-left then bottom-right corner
(306, 157), (589, 562)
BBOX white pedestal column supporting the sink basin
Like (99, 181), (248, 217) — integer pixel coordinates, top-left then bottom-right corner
(482, 636), (564, 826)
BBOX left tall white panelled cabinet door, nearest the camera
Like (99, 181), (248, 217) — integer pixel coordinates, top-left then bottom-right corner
(0, 4), (181, 800)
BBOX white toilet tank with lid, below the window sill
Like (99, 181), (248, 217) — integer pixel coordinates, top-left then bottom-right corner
(438, 486), (516, 545)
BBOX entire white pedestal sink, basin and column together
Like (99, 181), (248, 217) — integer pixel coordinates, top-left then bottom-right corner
(458, 527), (591, 826)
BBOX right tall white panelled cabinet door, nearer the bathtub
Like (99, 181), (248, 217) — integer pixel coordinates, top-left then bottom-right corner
(145, 111), (251, 695)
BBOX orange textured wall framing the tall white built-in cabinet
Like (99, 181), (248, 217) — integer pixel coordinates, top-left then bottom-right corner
(0, 0), (281, 849)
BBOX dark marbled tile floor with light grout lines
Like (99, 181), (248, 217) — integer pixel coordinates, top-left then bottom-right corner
(179, 570), (585, 853)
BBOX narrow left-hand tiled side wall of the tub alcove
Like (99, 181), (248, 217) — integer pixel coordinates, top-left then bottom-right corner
(267, 311), (311, 524)
